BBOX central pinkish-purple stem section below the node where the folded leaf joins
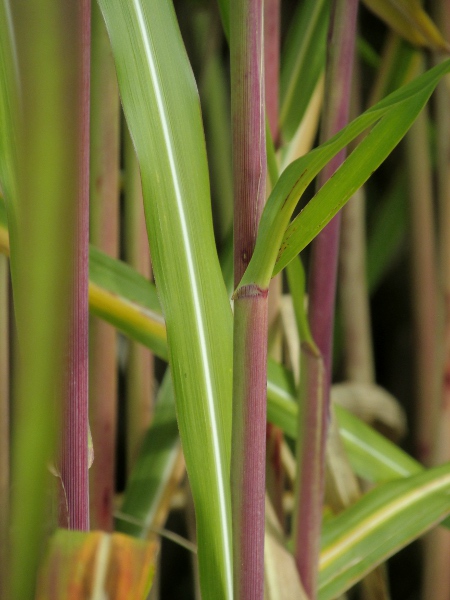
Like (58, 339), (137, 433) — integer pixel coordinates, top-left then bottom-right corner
(231, 288), (267, 600)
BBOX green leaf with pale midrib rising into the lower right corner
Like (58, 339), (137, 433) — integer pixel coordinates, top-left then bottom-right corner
(319, 463), (450, 600)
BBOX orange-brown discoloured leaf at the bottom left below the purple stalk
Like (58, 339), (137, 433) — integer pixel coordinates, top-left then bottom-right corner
(36, 529), (158, 600)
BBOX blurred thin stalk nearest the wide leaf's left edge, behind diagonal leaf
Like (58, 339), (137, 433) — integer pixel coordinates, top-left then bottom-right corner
(124, 125), (154, 473)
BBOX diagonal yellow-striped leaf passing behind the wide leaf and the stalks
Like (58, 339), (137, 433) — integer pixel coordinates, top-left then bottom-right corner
(0, 206), (432, 492)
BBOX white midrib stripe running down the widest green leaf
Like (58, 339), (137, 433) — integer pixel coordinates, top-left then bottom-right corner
(133, 0), (233, 597)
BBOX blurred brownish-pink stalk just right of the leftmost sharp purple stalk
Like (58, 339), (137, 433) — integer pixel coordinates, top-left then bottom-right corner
(89, 2), (120, 531)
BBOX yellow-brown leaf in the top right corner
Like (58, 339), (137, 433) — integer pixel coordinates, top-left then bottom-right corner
(364, 0), (450, 52)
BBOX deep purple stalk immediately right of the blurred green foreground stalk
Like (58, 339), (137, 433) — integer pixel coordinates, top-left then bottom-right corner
(61, 0), (91, 531)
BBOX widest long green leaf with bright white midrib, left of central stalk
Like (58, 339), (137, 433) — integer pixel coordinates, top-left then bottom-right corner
(96, 0), (232, 599)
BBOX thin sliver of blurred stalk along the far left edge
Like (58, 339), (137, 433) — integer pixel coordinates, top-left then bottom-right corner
(0, 256), (10, 600)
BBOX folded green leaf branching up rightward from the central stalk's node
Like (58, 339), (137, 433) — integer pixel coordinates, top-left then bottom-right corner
(239, 60), (450, 288)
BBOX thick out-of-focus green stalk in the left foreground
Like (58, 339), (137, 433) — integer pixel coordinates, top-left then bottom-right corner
(8, 0), (83, 600)
